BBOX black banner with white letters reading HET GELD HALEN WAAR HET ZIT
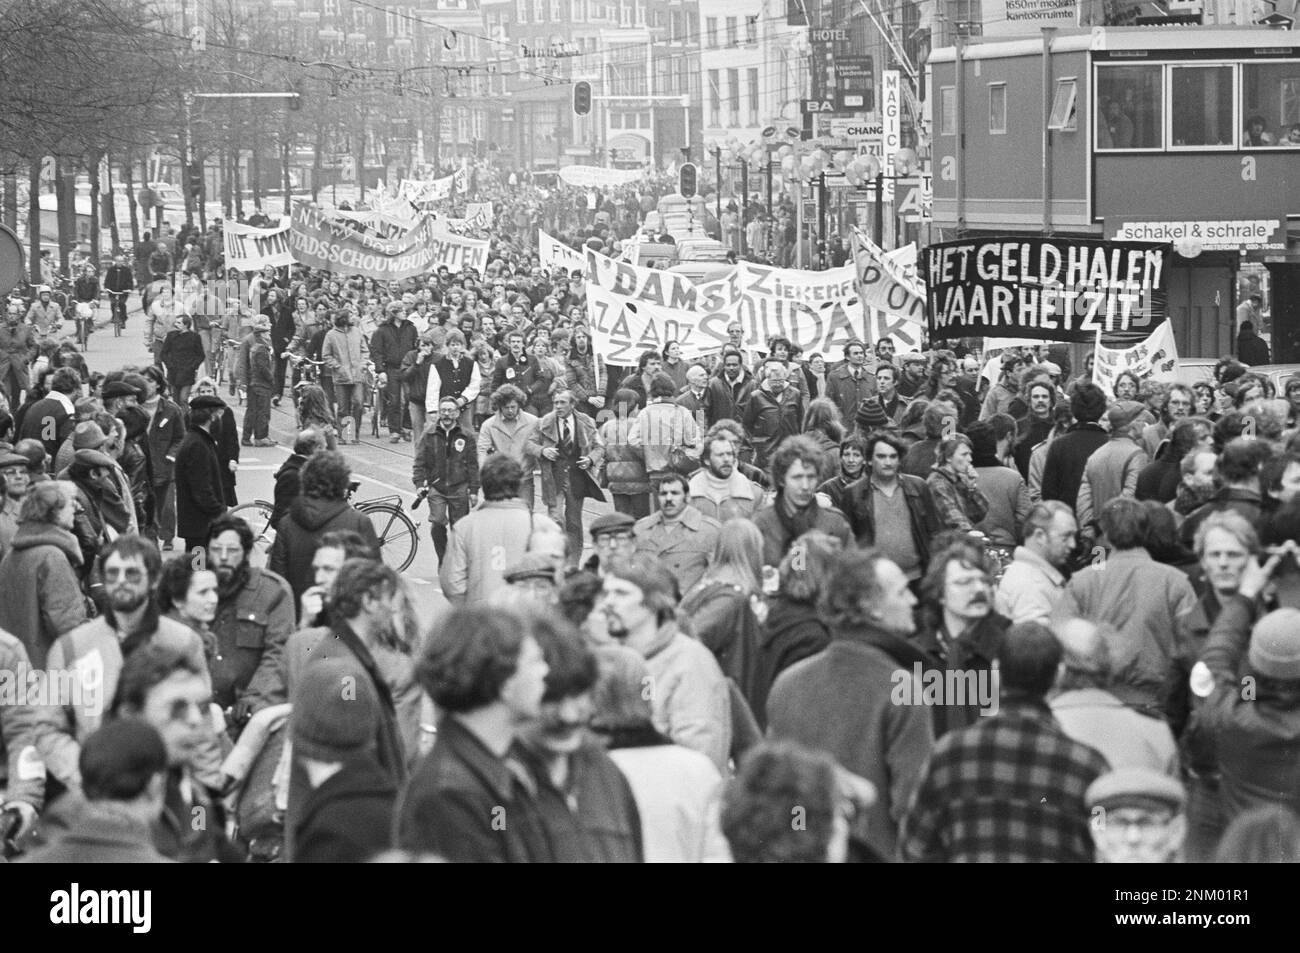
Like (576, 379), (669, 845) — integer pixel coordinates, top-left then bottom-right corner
(920, 238), (1173, 348)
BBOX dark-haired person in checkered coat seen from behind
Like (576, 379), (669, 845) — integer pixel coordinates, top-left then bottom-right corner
(898, 623), (1109, 863)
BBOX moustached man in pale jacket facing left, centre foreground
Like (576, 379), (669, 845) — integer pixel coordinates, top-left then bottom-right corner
(599, 553), (732, 771)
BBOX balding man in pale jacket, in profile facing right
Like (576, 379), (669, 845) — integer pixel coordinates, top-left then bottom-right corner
(995, 499), (1079, 624)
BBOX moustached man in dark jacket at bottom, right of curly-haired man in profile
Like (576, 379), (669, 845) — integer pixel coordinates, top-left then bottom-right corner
(519, 613), (644, 863)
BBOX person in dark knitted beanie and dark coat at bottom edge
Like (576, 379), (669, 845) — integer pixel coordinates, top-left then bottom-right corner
(289, 658), (397, 863)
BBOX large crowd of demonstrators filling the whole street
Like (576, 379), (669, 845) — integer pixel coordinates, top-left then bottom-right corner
(0, 174), (1300, 862)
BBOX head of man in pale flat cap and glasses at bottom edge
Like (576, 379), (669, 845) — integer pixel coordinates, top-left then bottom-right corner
(1084, 767), (1187, 863)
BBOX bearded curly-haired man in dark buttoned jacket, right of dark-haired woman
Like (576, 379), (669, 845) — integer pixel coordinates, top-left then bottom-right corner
(207, 515), (294, 735)
